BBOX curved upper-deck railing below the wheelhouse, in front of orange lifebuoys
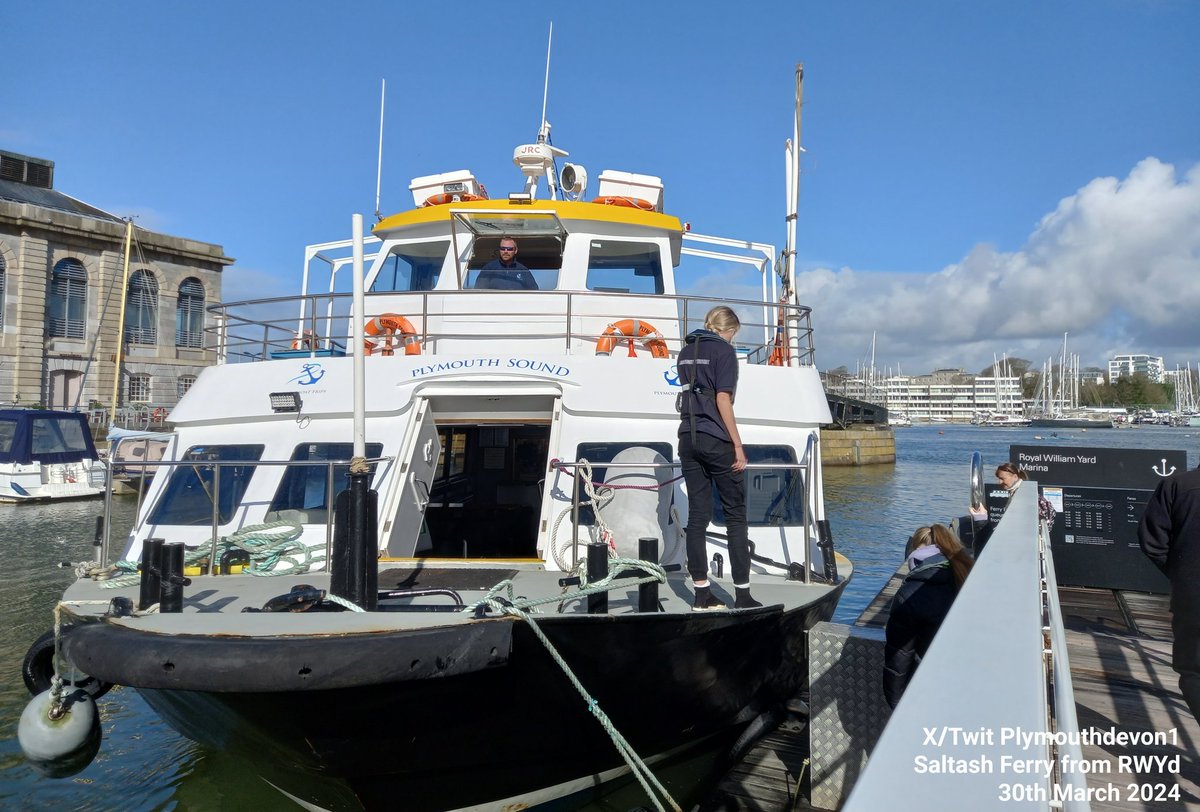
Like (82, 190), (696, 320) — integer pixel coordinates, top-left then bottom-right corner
(206, 290), (814, 366)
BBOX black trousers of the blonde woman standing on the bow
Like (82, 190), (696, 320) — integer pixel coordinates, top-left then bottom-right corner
(679, 431), (750, 584)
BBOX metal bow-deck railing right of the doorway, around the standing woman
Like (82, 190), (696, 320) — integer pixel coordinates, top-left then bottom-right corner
(551, 455), (836, 584)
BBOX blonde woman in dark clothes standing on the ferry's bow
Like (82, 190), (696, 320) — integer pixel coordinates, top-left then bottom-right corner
(678, 305), (762, 612)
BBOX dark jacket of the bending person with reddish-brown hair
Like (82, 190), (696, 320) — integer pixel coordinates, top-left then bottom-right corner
(883, 553), (959, 708)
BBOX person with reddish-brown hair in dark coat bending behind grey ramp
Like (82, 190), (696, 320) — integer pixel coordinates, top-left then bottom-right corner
(883, 524), (973, 708)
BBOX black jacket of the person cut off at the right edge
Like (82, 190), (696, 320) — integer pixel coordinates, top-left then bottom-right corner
(1138, 468), (1200, 624)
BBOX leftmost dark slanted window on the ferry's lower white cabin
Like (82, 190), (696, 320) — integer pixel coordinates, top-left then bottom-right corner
(150, 445), (263, 527)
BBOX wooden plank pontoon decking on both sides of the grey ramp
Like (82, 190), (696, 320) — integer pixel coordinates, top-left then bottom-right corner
(702, 572), (1200, 812)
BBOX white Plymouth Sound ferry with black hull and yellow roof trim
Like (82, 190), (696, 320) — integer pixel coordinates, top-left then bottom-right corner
(18, 72), (852, 812)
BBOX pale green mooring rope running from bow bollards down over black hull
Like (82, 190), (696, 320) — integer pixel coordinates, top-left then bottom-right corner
(466, 558), (682, 812)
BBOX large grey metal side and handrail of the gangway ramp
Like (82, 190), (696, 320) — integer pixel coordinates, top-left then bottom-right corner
(842, 482), (1091, 812)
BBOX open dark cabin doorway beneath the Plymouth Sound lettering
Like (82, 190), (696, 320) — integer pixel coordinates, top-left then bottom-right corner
(420, 397), (557, 559)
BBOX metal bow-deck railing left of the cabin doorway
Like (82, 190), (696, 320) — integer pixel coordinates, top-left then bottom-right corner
(97, 457), (395, 575)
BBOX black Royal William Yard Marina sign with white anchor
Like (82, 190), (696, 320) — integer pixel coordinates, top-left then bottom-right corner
(1009, 445), (1187, 594)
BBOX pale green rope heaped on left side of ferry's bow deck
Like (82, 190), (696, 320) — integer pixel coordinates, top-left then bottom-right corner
(94, 522), (309, 589)
